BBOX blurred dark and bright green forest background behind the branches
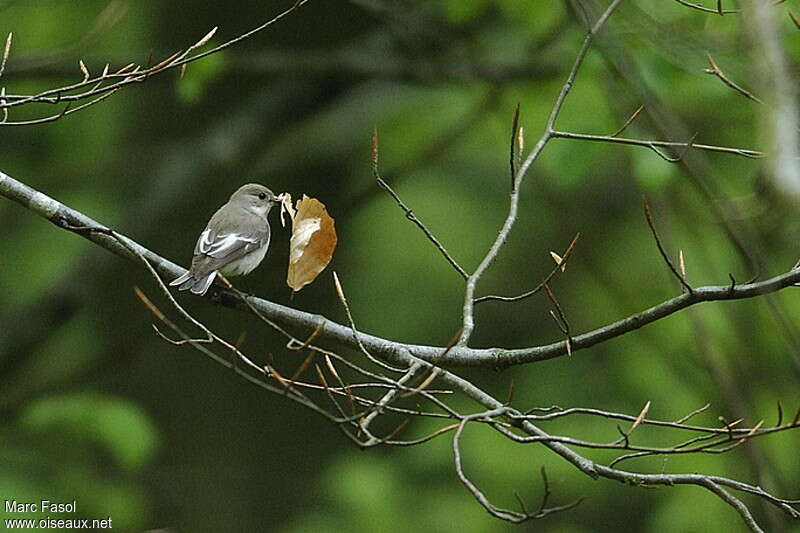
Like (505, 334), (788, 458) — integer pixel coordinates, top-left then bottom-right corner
(0, 0), (800, 533)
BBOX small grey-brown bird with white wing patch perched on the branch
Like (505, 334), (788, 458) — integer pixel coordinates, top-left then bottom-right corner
(170, 183), (279, 295)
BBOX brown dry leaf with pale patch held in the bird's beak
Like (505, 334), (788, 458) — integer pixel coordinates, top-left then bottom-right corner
(286, 195), (337, 292)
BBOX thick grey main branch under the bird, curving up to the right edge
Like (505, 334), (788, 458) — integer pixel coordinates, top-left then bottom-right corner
(0, 171), (800, 368)
